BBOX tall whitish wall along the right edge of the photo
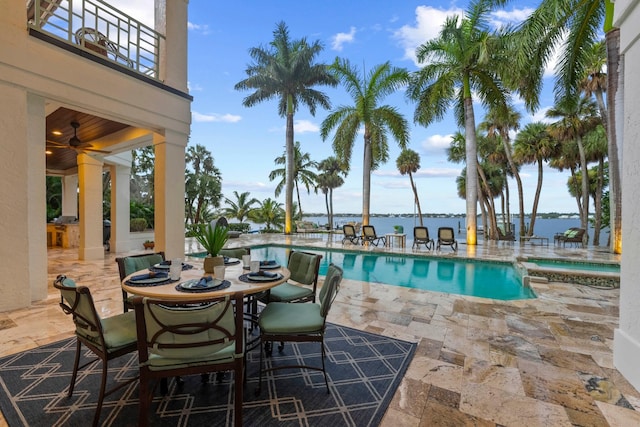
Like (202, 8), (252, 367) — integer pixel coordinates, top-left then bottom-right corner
(613, 1), (640, 390)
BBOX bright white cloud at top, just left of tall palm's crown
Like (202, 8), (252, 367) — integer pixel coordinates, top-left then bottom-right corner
(394, 6), (464, 65)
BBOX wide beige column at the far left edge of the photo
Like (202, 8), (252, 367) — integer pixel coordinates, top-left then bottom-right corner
(0, 89), (48, 312)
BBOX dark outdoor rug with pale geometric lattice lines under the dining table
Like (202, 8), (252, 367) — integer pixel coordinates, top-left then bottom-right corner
(0, 324), (416, 427)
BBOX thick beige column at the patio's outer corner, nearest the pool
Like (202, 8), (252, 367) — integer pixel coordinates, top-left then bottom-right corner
(154, 130), (187, 258)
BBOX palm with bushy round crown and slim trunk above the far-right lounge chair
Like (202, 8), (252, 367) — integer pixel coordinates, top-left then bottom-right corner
(546, 96), (601, 239)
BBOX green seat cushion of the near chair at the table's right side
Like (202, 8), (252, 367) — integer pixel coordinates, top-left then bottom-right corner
(258, 302), (324, 334)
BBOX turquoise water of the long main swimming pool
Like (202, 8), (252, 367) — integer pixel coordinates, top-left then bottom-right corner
(245, 246), (536, 300)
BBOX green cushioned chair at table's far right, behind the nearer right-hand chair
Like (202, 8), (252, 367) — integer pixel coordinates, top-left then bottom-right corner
(261, 251), (322, 304)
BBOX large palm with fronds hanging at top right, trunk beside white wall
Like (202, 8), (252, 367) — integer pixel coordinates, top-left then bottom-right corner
(504, 0), (624, 253)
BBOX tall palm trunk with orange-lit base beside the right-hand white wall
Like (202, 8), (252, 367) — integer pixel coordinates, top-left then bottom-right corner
(605, 28), (624, 254)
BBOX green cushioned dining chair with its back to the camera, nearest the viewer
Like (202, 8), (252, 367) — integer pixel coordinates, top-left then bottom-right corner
(132, 292), (245, 427)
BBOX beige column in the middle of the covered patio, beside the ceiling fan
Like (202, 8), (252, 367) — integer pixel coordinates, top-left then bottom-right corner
(78, 154), (104, 260)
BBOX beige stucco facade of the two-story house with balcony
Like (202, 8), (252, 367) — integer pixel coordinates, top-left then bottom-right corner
(0, 0), (191, 312)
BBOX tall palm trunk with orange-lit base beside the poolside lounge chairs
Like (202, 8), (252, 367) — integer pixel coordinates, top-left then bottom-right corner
(464, 95), (478, 245)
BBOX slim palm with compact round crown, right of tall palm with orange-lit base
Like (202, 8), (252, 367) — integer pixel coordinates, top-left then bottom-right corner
(513, 122), (559, 236)
